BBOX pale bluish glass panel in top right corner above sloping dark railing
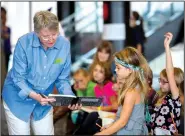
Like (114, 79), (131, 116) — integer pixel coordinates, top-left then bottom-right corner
(131, 2), (184, 32)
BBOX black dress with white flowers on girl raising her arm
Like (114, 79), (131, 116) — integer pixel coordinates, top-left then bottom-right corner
(151, 93), (181, 135)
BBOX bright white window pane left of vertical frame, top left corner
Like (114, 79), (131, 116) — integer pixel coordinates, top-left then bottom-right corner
(2, 2), (29, 48)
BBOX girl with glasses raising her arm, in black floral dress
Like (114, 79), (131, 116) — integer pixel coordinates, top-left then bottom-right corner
(151, 33), (184, 135)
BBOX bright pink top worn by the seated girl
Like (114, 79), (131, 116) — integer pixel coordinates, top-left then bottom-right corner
(94, 81), (117, 106)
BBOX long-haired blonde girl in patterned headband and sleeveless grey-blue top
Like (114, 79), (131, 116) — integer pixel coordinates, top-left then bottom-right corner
(96, 47), (149, 135)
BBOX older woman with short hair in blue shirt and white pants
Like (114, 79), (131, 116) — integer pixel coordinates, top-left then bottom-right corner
(2, 11), (79, 135)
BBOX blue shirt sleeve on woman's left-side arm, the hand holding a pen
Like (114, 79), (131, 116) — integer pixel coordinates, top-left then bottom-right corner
(11, 41), (32, 100)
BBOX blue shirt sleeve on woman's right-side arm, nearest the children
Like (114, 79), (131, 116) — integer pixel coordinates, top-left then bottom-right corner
(55, 42), (74, 95)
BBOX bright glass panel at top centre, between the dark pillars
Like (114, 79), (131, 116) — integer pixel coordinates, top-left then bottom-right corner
(75, 2), (103, 32)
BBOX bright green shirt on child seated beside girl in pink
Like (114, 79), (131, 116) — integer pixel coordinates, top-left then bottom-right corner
(77, 81), (96, 97)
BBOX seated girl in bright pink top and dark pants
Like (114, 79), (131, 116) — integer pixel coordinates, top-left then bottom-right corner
(75, 62), (118, 135)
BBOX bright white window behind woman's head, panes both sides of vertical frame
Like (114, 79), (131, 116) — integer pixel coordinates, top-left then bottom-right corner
(2, 2), (57, 48)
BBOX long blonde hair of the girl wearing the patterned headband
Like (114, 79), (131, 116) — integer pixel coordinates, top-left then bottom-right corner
(115, 47), (150, 105)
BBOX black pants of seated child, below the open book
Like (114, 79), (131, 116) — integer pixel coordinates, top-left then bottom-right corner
(74, 112), (102, 135)
